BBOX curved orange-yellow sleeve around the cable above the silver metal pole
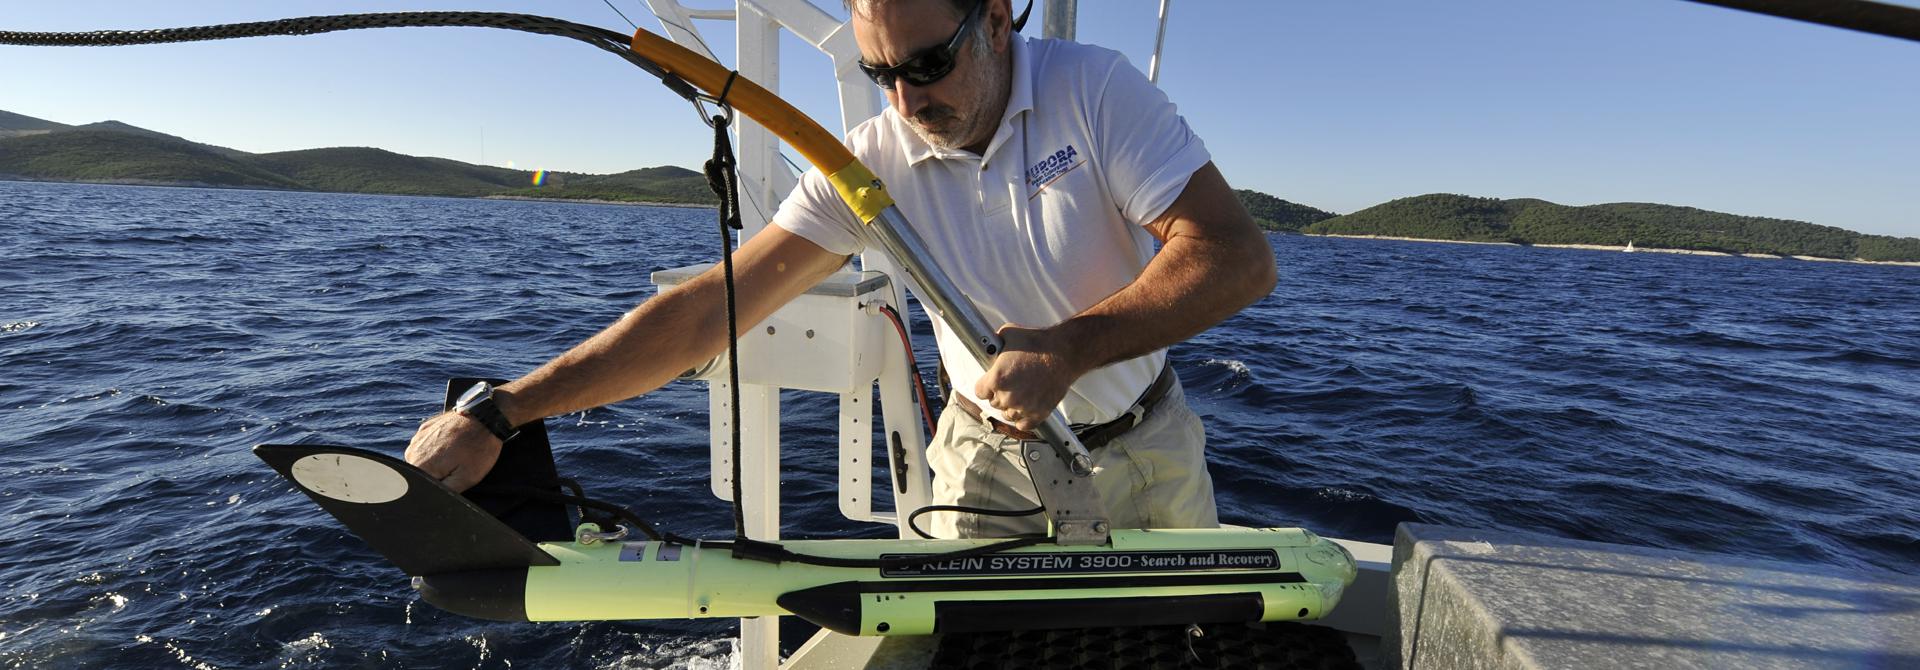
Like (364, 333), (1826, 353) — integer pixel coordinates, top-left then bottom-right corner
(634, 31), (893, 223)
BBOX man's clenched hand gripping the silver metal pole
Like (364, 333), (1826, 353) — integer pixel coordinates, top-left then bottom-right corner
(973, 324), (1087, 432)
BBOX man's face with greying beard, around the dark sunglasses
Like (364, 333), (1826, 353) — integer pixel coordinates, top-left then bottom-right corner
(852, 0), (1006, 148)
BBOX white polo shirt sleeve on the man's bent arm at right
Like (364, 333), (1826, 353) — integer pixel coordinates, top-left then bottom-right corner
(1089, 54), (1213, 225)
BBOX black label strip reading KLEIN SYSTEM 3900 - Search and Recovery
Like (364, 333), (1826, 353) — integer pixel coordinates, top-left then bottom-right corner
(879, 549), (1281, 578)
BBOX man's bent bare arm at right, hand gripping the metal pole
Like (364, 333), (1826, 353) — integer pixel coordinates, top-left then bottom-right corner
(975, 163), (1277, 430)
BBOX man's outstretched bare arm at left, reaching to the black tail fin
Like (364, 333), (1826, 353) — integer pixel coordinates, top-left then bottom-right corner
(407, 227), (847, 490)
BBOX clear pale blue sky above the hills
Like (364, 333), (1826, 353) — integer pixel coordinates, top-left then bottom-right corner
(0, 0), (1920, 236)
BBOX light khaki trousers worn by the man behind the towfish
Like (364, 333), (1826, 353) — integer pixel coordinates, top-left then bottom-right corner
(922, 376), (1219, 538)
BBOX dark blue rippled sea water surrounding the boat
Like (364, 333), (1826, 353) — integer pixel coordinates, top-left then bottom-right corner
(0, 182), (1920, 668)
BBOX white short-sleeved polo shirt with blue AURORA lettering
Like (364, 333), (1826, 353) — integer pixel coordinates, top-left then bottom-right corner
(772, 35), (1212, 424)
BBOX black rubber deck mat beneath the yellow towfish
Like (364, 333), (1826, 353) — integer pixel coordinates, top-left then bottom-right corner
(931, 622), (1361, 670)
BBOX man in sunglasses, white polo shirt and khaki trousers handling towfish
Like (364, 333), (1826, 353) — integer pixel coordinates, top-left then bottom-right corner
(407, 0), (1275, 538)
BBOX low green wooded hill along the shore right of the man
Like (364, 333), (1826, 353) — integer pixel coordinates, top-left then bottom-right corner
(1302, 194), (1920, 261)
